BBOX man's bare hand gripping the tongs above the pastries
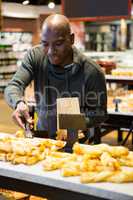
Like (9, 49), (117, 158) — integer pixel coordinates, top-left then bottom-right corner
(12, 101), (33, 129)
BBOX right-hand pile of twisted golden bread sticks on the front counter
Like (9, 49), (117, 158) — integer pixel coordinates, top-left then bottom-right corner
(43, 143), (133, 183)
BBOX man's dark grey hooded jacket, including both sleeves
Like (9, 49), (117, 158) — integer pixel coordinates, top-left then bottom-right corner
(5, 45), (107, 137)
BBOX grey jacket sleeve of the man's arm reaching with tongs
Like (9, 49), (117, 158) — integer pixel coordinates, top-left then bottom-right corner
(4, 50), (33, 109)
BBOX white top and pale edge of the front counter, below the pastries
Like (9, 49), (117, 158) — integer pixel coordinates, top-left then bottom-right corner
(0, 161), (133, 200)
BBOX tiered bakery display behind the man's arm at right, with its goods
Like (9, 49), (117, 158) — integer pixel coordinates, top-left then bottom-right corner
(85, 50), (133, 145)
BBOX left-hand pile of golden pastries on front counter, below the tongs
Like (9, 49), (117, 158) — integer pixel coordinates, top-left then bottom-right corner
(0, 136), (65, 165)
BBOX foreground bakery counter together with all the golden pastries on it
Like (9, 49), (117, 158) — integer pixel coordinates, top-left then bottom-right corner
(0, 133), (133, 200)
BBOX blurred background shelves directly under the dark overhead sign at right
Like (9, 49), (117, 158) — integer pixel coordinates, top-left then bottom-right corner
(85, 19), (133, 52)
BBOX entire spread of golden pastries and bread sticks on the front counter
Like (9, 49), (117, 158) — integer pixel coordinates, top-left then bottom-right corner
(0, 136), (133, 183)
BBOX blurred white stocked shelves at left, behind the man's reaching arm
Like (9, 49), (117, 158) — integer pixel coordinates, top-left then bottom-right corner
(0, 32), (32, 92)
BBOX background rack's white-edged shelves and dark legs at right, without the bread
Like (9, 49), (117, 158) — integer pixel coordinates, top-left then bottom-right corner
(101, 75), (133, 145)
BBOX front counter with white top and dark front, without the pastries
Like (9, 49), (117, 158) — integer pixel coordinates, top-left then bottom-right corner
(0, 133), (133, 200)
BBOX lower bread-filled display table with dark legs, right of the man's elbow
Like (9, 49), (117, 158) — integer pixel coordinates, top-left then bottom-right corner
(101, 75), (133, 145)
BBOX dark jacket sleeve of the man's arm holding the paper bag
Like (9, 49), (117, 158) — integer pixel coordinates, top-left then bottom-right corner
(84, 63), (107, 128)
